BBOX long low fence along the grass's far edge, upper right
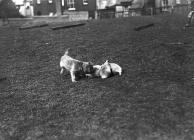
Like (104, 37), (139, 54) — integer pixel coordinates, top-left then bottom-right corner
(97, 4), (189, 19)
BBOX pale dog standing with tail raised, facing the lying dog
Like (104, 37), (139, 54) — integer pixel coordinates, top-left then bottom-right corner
(60, 49), (94, 82)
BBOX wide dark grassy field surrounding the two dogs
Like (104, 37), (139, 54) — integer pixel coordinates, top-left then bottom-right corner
(0, 16), (194, 140)
